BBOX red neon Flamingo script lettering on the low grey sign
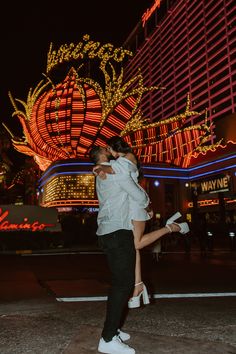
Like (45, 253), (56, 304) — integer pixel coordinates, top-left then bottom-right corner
(0, 208), (55, 232)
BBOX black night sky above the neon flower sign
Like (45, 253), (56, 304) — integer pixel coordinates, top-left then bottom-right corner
(0, 0), (154, 139)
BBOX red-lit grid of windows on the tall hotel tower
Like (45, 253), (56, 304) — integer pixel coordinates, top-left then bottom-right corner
(126, 0), (236, 134)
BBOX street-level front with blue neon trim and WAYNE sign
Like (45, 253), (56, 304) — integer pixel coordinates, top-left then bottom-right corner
(143, 143), (236, 232)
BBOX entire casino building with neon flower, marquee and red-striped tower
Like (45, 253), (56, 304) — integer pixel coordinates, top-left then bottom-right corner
(7, 0), (236, 235)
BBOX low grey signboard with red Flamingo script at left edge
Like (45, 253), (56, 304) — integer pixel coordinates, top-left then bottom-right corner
(0, 205), (61, 232)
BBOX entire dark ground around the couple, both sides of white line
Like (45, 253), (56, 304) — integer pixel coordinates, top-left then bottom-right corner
(0, 246), (236, 354)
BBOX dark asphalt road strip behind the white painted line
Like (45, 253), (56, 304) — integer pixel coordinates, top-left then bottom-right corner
(0, 248), (236, 301)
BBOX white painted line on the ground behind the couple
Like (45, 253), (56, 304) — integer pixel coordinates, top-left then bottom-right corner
(56, 292), (236, 302)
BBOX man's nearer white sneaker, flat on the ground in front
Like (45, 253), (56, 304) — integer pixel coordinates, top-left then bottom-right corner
(98, 336), (135, 354)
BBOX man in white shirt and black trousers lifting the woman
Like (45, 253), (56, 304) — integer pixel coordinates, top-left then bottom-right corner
(90, 146), (149, 354)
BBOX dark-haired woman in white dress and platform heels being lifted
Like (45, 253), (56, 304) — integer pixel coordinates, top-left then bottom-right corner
(93, 136), (186, 308)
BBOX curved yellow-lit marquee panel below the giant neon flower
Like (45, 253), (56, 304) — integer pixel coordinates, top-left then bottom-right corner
(41, 172), (97, 207)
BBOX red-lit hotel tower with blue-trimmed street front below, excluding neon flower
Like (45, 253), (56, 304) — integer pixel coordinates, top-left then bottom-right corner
(122, 0), (236, 227)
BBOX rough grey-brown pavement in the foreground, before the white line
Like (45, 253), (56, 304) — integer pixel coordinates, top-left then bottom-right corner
(0, 298), (236, 354)
